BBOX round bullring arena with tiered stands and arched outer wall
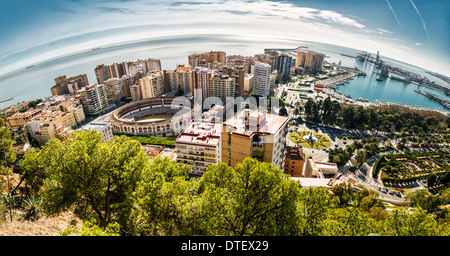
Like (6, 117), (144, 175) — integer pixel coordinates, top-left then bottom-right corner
(110, 97), (194, 137)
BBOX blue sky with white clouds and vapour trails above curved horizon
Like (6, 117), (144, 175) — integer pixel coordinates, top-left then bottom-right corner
(0, 0), (450, 76)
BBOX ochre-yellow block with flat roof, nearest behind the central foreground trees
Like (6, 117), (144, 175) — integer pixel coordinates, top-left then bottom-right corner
(222, 109), (289, 169)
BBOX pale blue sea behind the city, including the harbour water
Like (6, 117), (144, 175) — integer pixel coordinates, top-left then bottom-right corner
(0, 35), (450, 110)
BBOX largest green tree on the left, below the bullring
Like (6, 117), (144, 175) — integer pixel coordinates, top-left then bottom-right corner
(24, 130), (148, 229)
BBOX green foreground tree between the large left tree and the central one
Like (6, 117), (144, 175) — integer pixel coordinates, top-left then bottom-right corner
(133, 157), (202, 235)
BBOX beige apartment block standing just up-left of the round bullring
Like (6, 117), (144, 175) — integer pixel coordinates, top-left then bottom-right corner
(76, 84), (108, 115)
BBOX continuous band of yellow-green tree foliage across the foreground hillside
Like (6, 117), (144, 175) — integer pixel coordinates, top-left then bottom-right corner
(13, 131), (450, 236)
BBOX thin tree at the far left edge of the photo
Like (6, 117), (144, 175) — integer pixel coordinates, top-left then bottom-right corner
(0, 118), (16, 221)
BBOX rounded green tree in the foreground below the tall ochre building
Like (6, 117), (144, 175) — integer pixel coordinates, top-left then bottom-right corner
(200, 158), (300, 236)
